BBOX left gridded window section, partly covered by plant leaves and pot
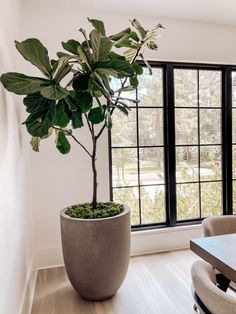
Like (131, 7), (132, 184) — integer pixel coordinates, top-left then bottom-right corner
(111, 67), (166, 225)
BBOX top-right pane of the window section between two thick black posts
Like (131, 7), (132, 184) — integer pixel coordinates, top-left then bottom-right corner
(199, 70), (221, 107)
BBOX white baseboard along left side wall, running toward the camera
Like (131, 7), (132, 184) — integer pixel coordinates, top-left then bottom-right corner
(19, 262), (37, 314)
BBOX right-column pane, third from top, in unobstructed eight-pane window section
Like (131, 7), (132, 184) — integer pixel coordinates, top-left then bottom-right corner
(200, 146), (222, 181)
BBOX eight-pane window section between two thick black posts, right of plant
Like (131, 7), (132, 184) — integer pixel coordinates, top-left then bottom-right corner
(174, 69), (223, 221)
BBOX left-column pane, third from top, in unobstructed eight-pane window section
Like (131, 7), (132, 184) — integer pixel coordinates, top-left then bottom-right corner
(176, 146), (199, 182)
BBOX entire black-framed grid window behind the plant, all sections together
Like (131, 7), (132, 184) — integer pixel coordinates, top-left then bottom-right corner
(109, 62), (236, 228)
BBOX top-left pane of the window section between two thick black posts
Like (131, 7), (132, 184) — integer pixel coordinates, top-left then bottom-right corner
(174, 69), (198, 107)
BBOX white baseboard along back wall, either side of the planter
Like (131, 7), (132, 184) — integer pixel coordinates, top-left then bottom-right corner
(34, 225), (201, 269)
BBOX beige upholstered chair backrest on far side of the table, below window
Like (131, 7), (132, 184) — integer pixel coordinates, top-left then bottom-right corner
(202, 215), (236, 237)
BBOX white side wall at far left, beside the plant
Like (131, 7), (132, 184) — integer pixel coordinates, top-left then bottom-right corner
(0, 0), (33, 314)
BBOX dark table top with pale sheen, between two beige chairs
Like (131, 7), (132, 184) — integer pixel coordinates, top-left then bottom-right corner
(190, 233), (236, 282)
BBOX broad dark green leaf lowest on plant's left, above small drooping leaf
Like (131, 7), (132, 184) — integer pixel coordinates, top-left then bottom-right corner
(24, 104), (56, 137)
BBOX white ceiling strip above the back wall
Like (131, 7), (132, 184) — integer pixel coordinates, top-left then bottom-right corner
(23, 0), (236, 26)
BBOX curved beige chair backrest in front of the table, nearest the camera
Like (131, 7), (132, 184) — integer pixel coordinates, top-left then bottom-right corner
(191, 260), (236, 314)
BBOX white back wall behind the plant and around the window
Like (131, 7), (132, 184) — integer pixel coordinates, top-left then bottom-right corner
(19, 1), (236, 266)
